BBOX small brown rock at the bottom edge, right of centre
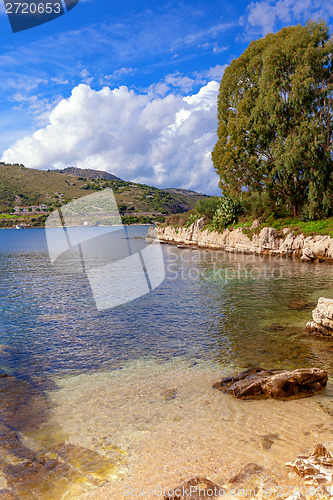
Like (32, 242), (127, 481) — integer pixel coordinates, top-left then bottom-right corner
(164, 477), (225, 500)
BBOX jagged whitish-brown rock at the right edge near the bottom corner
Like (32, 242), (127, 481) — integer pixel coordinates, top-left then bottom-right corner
(286, 443), (333, 484)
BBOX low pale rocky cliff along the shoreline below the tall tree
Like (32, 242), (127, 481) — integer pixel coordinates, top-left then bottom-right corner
(148, 219), (333, 262)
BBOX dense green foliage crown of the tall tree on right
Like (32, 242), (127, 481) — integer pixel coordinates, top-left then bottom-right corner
(212, 22), (333, 219)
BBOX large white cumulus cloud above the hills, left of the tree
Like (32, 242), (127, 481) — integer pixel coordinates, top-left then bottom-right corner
(1, 81), (219, 194)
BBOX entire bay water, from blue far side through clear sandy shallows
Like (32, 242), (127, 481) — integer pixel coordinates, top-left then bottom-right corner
(0, 226), (333, 500)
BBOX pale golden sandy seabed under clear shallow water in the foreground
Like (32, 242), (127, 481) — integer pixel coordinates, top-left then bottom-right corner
(38, 359), (333, 500)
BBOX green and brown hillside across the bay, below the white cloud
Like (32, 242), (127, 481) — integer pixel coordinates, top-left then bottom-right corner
(0, 163), (206, 227)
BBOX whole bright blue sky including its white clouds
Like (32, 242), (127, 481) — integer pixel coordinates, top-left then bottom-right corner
(0, 0), (333, 194)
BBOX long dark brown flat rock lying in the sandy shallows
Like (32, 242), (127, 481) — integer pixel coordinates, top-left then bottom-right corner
(213, 368), (327, 400)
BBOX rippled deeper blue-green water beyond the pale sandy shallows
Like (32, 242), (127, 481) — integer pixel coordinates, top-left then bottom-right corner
(0, 226), (333, 372)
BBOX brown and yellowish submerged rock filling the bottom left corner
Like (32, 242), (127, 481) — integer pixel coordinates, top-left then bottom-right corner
(0, 366), (124, 500)
